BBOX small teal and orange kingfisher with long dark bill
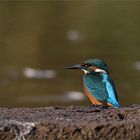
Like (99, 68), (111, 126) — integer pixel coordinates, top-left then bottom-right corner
(65, 59), (120, 108)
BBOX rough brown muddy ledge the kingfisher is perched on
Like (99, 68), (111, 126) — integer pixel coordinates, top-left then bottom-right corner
(0, 105), (140, 140)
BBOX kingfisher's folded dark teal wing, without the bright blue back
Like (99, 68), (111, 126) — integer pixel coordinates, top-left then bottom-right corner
(84, 75), (108, 102)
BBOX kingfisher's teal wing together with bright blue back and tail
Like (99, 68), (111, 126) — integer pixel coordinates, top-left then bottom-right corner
(83, 73), (120, 108)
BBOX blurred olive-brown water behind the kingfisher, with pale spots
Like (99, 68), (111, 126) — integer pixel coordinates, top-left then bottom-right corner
(0, 0), (140, 107)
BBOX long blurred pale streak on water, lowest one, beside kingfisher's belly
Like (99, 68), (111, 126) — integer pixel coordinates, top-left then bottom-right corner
(17, 91), (85, 105)
